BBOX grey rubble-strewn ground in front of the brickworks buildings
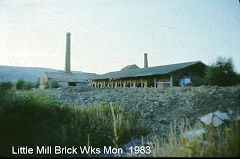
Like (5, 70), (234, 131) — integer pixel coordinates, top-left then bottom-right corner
(30, 86), (240, 134)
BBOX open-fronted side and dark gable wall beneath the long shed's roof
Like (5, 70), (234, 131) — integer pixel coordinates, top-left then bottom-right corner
(92, 63), (206, 88)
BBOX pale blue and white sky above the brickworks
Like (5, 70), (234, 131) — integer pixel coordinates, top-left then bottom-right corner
(0, 0), (240, 73)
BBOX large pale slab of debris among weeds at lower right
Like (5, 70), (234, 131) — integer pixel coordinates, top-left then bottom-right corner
(199, 111), (230, 127)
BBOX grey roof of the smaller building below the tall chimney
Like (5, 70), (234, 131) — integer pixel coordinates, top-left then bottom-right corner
(44, 71), (96, 82)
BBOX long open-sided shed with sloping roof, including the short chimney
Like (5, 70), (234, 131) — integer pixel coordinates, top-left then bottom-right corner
(92, 54), (206, 88)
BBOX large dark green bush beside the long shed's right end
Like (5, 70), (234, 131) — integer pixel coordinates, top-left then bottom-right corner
(204, 57), (238, 86)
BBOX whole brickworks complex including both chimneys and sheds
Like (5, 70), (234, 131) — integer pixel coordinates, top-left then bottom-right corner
(40, 33), (206, 88)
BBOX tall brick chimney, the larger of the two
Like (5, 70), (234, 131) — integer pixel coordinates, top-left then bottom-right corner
(65, 32), (71, 73)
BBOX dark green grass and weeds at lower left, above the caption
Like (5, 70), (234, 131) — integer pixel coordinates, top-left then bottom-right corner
(0, 93), (146, 156)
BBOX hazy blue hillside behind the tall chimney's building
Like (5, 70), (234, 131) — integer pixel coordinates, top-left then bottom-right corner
(0, 66), (97, 82)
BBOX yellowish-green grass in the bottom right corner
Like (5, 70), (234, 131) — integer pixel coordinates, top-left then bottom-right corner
(150, 121), (240, 157)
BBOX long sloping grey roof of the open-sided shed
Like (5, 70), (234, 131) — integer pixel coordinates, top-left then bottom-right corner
(93, 61), (205, 80)
